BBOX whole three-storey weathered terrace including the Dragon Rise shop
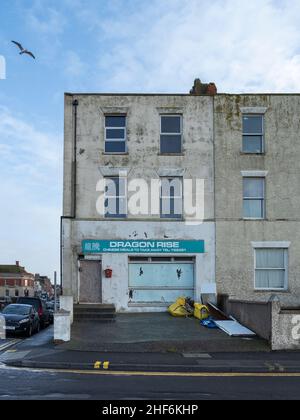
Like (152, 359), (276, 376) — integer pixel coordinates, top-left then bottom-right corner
(62, 80), (300, 348)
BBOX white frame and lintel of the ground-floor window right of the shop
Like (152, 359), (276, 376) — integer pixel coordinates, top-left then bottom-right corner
(252, 242), (290, 292)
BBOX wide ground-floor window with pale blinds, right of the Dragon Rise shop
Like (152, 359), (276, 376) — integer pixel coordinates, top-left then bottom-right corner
(255, 248), (288, 290)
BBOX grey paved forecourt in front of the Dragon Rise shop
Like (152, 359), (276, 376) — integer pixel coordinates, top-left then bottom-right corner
(61, 313), (270, 353)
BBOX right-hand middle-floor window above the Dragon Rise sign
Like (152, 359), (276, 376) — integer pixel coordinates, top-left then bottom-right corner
(160, 177), (183, 219)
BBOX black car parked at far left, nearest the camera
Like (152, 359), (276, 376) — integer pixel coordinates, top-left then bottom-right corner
(1, 304), (40, 337)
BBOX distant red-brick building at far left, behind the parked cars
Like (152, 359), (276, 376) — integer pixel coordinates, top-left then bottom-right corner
(0, 261), (34, 298)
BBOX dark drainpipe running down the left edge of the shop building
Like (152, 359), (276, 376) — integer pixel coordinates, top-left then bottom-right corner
(60, 99), (79, 294)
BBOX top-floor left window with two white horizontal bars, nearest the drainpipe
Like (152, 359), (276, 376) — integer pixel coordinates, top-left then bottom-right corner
(105, 115), (126, 153)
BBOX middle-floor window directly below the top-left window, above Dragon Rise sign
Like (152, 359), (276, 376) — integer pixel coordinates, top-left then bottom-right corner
(104, 177), (127, 218)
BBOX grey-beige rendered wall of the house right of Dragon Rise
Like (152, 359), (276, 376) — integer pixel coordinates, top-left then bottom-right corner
(214, 95), (300, 304)
